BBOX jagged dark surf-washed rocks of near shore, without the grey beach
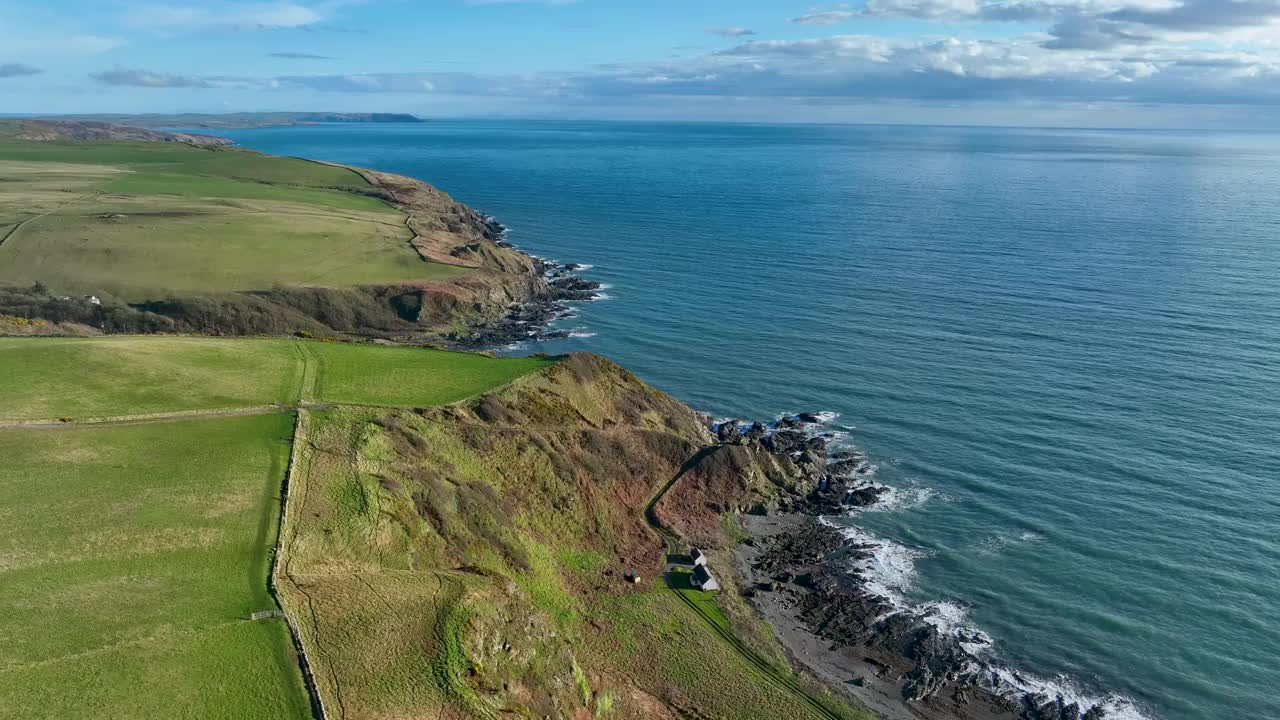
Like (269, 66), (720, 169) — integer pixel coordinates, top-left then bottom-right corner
(732, 414), (1121, 720)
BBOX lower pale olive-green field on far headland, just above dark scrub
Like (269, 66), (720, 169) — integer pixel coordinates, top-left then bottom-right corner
(0, 196), (466, 297)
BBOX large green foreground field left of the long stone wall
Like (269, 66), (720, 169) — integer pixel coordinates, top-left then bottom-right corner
(0, 415), (310, 720)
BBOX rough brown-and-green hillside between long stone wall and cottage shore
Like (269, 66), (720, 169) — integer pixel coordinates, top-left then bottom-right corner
(282, 355), (849, 720)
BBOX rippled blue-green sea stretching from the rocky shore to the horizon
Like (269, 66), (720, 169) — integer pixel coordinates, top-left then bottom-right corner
(225, 122), (1280, 720)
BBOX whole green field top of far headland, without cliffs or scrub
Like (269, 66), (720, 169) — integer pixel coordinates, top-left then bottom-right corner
(0, 140), (466, 301)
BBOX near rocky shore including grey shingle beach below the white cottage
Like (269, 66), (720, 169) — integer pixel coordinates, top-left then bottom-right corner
(713, 413), (1108, 720)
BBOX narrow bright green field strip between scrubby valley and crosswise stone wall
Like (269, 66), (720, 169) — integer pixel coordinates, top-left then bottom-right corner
(0, 336), (549, 421)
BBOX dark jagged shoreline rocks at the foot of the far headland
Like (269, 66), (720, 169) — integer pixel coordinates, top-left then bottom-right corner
(445, 215), (603, 351)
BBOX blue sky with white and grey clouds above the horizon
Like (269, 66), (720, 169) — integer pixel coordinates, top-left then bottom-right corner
(0, 0), (1280, 129)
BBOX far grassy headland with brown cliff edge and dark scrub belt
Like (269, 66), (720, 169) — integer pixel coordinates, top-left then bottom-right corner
(0, 120), (549, 338)
